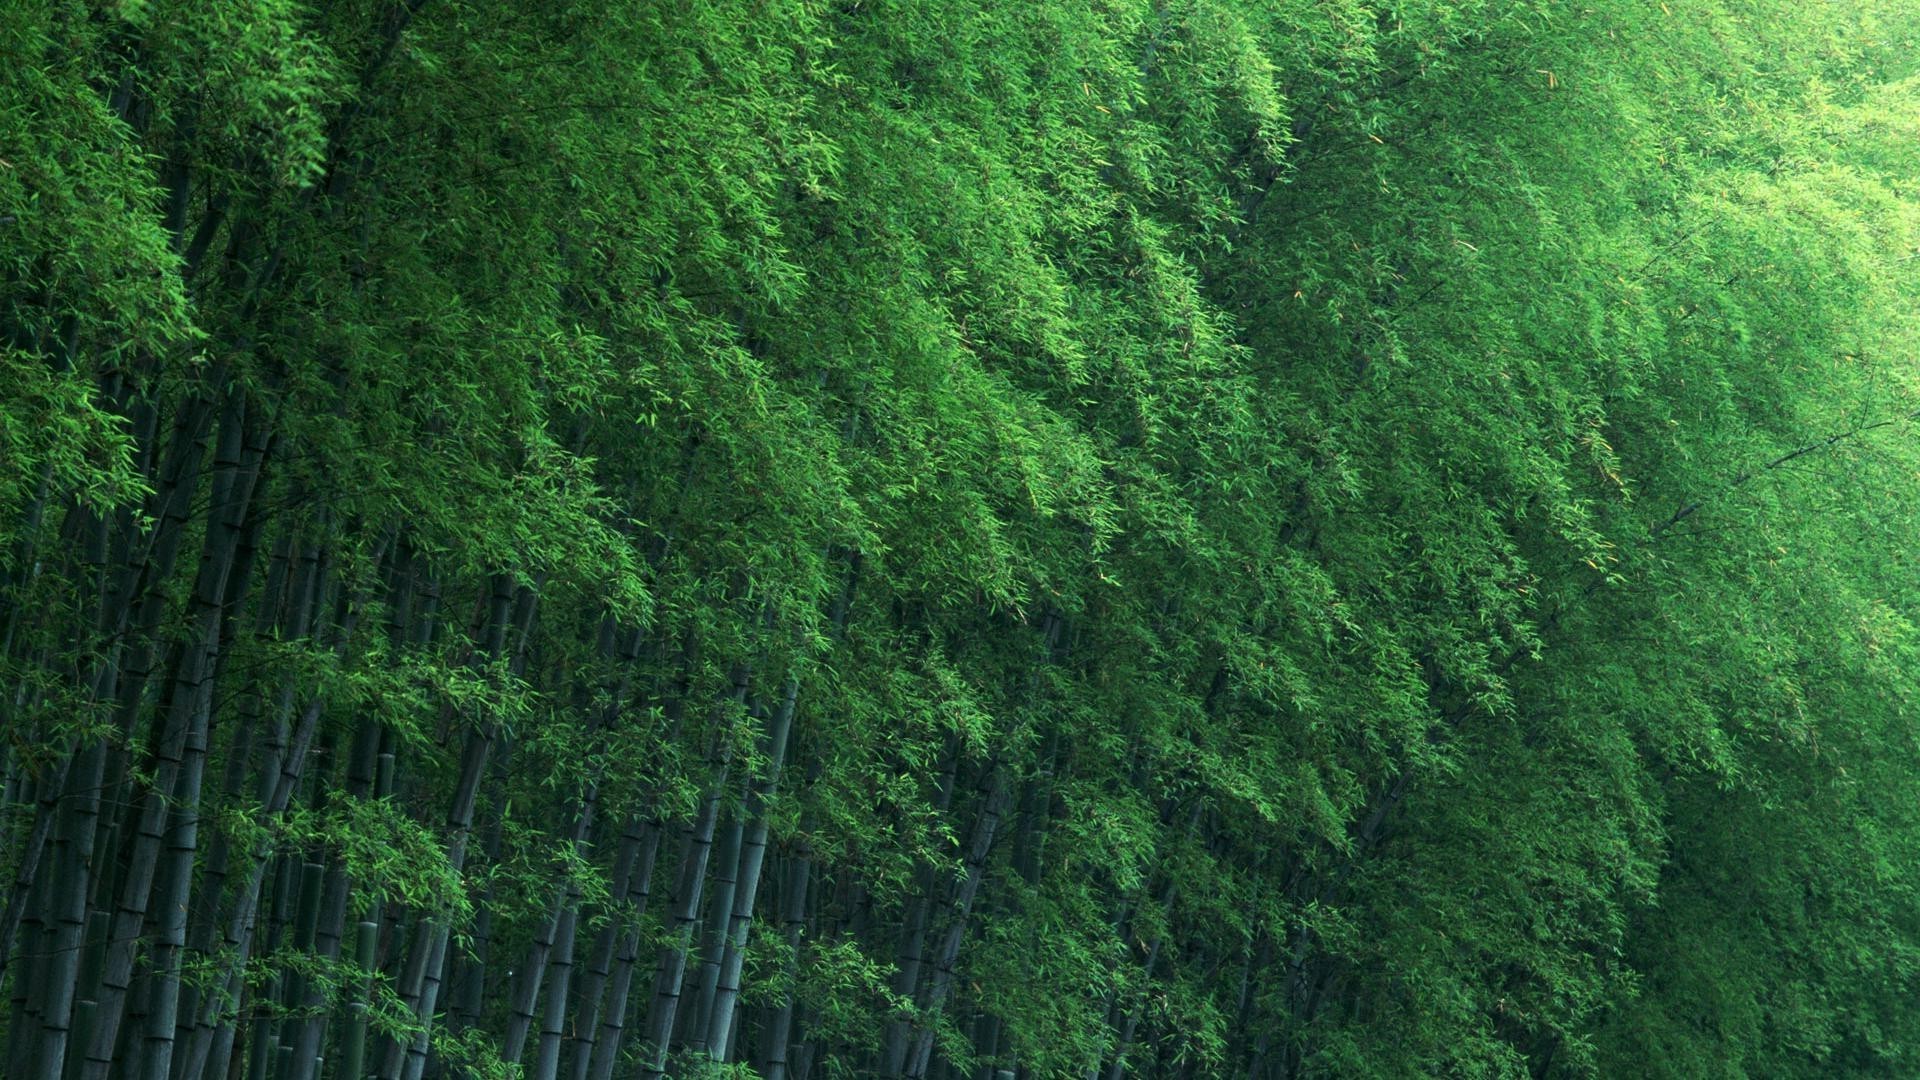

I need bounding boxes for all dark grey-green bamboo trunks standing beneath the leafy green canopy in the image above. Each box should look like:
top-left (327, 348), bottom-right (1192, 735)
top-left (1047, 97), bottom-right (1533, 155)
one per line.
top-left (0, 424), bottom-right (1169, 1080)
